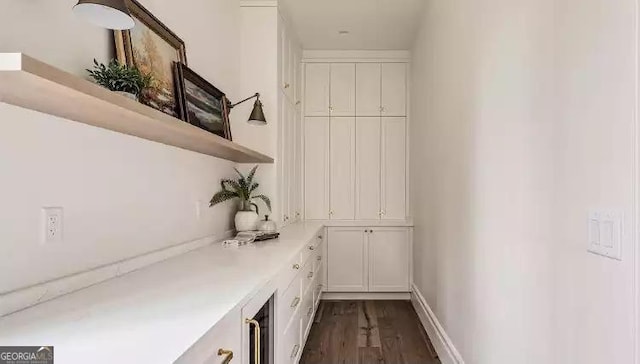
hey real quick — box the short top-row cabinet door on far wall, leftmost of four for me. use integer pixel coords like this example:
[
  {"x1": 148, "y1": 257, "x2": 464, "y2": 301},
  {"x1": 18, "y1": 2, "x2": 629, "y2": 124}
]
[{"x1": 304, "y1": 63, "x2": 331, "y2": 116}]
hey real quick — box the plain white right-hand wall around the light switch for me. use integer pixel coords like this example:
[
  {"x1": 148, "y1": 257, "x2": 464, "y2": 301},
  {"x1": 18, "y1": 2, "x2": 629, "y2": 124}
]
[{"x1": 411, "y1": 0, "x2": 636, "y2": 364}]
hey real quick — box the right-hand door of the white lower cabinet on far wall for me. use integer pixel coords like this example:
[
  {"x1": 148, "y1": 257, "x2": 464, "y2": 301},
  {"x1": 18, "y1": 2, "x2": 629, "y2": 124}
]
[{"x1": 367, "y1": 227, "x2": 411, "y2": 292}]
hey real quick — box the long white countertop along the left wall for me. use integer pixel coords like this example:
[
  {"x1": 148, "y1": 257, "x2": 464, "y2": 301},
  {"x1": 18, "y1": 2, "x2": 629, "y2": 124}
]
[{"x1": 0, "y1": 222, "x2": 323, "y2": 364}]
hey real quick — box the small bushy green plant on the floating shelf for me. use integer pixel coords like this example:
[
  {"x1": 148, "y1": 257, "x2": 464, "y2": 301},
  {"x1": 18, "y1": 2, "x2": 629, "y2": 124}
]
[{"x1": 87, "y1": 59, "x2": 153, "y2": 100}]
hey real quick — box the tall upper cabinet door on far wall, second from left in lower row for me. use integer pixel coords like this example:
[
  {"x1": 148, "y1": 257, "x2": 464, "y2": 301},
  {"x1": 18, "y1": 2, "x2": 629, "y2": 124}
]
[{"x1": 329, "y1": 117, "x2": 356, "y2": 220}]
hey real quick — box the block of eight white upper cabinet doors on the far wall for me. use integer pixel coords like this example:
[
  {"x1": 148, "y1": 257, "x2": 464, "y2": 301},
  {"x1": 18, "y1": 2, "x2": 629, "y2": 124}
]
[{"x1": 304, "y1": 63, "x2": 407, "y2": 220}]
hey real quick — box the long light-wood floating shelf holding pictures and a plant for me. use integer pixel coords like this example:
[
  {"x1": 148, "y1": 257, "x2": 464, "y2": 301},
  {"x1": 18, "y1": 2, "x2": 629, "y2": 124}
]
[{"x1": 0, "y1": 53, "x2": 273, "y2": 163}]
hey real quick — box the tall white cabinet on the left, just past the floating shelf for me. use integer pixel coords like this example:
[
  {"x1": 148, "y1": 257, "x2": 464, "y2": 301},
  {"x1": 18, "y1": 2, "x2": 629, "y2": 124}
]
[{"x1": 240, "y1": 2, "x2": 304, "y2": 225}]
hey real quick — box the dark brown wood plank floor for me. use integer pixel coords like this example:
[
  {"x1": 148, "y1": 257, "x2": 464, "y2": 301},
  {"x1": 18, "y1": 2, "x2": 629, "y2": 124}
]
[{"x1": 300, "y1": 301, "x2": 440, "y2": 364}]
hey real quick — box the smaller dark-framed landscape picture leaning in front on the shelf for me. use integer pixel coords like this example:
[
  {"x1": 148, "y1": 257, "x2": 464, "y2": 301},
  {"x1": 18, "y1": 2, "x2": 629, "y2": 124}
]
[{"x1": 174, "y1": 62, "x2": 231, "y2": 140}]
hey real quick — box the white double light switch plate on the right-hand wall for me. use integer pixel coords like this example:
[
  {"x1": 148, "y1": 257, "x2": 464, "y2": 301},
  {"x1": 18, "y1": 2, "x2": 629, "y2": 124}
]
[{"x1": 587, "y1": 210, "x2": 623, "y2": 260}]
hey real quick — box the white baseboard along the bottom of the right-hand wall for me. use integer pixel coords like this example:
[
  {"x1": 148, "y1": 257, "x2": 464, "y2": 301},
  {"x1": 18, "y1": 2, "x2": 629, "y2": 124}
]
[{"x1": 411, "y1": 284, "x2": 464, "y2": 364}]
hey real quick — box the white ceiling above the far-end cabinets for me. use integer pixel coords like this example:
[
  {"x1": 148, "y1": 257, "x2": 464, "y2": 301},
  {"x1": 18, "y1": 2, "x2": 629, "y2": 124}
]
[{"x1": 281, "y1": 0, "x2": 425, "y2": 50}]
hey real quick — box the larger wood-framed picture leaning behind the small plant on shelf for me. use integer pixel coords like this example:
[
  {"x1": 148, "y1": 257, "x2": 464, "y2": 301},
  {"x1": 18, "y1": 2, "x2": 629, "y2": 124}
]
[{"x1": 114, "y1": 0, "x2": 187, "y2": 117}]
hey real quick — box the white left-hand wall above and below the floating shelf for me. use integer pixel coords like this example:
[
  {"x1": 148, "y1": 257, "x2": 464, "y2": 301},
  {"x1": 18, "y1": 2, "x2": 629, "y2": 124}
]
[{"x1": 0, "y1": 0, "x2": 246, "y2": 293}]
